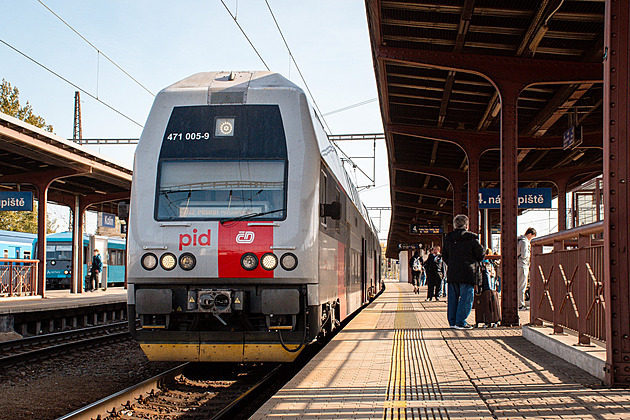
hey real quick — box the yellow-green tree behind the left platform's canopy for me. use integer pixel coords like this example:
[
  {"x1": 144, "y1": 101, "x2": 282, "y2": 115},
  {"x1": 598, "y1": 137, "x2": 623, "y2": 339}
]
[{"x1": 0, "y1": 79, "x2": 56, "y2": 233}]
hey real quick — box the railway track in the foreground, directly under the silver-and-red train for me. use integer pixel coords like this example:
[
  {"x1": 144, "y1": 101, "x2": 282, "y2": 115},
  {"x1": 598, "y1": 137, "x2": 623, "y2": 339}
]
[{"x1": 58, "y1": 363, "x2": 284, "y2": 420}]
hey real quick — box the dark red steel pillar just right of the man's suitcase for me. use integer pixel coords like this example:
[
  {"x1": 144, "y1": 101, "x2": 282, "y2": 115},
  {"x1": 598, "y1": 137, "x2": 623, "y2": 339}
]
[{"x1": 499, "y1": 83, "x2": 521, "y2": 326}]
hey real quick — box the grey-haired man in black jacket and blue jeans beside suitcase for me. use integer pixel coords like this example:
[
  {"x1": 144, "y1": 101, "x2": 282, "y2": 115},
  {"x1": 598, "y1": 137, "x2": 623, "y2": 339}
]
[{"x1": 442, "y1": 214, "x2": 485, "y2": 329}]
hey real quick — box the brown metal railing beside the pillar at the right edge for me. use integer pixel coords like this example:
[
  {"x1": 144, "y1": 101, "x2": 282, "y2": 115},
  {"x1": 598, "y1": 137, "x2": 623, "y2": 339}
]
[{"x1": 530, "y1": 221, "x2": 606, "y2": 345}]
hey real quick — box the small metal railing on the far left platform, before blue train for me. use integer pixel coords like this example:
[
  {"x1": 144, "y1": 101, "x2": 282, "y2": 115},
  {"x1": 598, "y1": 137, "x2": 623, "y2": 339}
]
[{"x1": 0, "y1": 258, "x2": 39, "y2": 296}]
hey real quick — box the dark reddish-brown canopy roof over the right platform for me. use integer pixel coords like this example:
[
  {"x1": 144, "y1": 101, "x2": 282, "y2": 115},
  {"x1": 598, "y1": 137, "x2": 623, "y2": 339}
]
[{"x1": 366, "y1": 0, "x2": 606, "y2": 257}]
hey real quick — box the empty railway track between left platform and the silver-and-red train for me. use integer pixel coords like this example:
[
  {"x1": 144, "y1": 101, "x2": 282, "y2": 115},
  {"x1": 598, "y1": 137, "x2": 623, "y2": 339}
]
[{"x1": 0, "y1": 321, "x2": 129, "y2": 366}]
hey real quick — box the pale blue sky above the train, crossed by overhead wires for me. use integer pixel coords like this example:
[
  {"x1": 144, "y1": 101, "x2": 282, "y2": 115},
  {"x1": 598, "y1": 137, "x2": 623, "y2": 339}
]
[{"x1": 0, "y1": 0, "x2": 389, "y2": 238}]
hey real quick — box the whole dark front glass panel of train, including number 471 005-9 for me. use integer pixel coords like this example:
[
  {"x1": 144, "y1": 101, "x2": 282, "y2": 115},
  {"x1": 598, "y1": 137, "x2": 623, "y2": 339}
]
[{"x1": 154, "y1": 105, "x2": 289, "y2": 220}]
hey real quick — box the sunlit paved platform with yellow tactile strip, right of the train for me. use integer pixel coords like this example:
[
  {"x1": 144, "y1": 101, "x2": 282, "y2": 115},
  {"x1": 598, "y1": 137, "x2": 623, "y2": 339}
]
[{"x1": 252, "y1": 283, "x2": 630, "y2": 419}]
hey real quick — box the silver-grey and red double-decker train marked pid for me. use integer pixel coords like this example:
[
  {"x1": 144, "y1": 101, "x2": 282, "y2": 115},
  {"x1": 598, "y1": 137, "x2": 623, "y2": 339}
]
[{"x1": 128, "y1": 72, "x2": 381, "y2": 362}]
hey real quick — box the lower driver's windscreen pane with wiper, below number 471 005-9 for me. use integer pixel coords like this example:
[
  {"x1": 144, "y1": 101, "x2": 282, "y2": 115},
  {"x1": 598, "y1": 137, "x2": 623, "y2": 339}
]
[{"x1": 157, "y1": 160, "x2": 285, "y2": 220}]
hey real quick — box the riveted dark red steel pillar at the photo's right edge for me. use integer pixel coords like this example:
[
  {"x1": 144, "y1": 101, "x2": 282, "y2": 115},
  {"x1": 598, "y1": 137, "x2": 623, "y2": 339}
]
[{"x1": 603, "y1": 0, "x2": 630, "y2": 386}]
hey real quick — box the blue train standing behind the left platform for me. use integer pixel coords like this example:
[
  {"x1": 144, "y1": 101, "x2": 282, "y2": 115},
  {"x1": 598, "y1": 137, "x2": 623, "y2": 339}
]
[{"x1": 0, "y1": 230, "x2": 126, "y2": 289}]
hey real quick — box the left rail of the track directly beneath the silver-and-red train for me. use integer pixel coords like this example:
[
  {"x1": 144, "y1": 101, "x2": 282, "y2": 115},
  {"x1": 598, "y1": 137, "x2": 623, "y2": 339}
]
[{"x1": 57, "y1": 363, "x2": 188, "y2": 420}]
